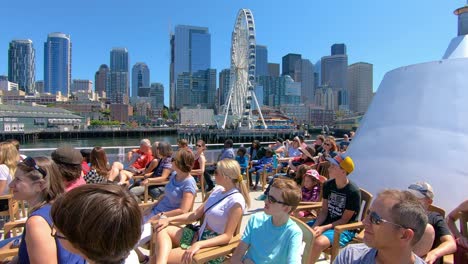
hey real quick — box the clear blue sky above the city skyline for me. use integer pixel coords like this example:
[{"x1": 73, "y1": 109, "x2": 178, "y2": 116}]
[{"x1": 0, "y1": 0, "x2": 460, "y2": 104}]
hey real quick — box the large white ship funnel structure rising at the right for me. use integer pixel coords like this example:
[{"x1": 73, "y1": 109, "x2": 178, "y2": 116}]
[{"x1": 348, "y1": 3, "x2": 468, "y2": 211}]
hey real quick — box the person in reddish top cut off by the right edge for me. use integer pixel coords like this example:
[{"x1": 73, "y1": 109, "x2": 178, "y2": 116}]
[{"x1": 447, "y1": 200, "x2": 468, "y2": 264}]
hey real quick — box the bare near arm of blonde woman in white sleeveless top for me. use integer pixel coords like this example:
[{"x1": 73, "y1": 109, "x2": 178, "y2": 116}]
[{"x1": 182, "y1": 203, "x2": 242, "y2": 263}]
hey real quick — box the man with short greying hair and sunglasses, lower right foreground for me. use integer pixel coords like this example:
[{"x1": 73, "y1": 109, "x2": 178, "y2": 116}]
[{"x1": 334, "y1": 190, "x2": 427, "y2": 264}]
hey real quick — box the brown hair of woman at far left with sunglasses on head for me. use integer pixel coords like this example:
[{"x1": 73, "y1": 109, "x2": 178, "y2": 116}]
[{"x1": 17, "y1": 157, "x2": 65, "y2": 214}]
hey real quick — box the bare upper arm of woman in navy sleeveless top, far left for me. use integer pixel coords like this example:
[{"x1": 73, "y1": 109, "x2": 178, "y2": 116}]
[{"x1": 26, "y1": 216, "x2": 58, "y2": 264}]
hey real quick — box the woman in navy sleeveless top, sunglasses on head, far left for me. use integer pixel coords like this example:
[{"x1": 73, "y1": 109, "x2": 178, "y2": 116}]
[{"x1": 10, "y1": 157, "x2": 85, "y2": 264}]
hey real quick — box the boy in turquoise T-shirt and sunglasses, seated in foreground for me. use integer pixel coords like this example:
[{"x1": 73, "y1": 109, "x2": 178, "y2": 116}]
[{"x1": 231, "y1": 178, "x2": 302, "y2": 263}]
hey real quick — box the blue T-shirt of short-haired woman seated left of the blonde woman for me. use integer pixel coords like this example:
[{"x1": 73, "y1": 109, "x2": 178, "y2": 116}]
[{"x1": 152, "y1": 175, "x2": 197, "y2": 215}]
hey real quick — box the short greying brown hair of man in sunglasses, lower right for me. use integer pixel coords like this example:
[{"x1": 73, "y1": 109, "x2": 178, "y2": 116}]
[{"x1": 377, "y1": 190, "x2": 428, "y2": 245}]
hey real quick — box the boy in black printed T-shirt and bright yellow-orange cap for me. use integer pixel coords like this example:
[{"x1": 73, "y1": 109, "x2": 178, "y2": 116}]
[{"x1": 307, "y1": 155, "x2": 361, "y2": 263}]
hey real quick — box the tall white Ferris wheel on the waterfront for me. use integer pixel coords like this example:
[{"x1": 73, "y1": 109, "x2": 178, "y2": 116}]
[{"x1": 222, "y1": 9, "x2": 267, "y2": 129}]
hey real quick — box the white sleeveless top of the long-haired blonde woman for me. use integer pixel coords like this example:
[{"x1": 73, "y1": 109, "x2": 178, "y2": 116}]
[{"x1": 199, "y1": 186, "x2": 245, "y2": 239}]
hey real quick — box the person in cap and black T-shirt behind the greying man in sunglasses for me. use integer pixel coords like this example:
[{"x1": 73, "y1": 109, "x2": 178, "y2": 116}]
[{"x1": 408, "y1": 182, "x2": 457, "y2": 264}]
